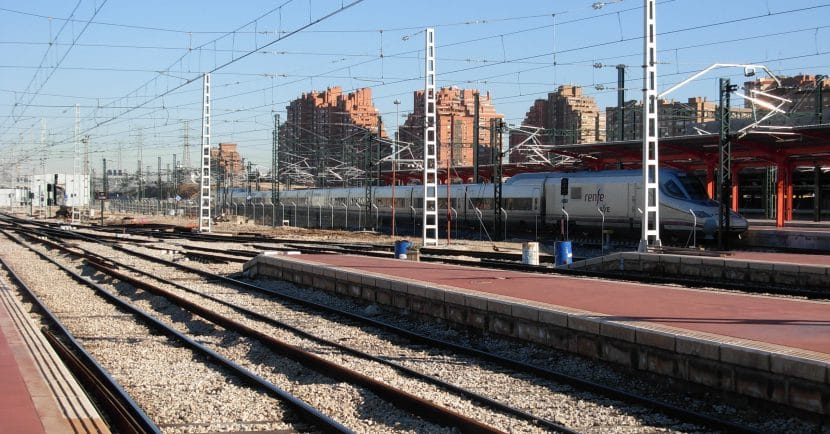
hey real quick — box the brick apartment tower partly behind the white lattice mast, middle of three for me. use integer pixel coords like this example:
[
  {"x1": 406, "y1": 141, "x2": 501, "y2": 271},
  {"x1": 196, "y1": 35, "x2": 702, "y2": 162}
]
[{"x1": 399, "y1": 86, "x2": 504, "y2": 178}]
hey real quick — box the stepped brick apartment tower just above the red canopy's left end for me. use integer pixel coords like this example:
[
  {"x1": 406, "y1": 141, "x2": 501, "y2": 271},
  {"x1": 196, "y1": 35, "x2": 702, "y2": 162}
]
[{"x1": 510, "y1": 85, "x2": 605, "y2": 162}]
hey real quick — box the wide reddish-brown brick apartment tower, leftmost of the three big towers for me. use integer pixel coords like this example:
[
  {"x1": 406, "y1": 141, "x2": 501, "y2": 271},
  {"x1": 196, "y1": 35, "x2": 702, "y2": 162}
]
[{"x1": 280, "y1": 86, "x2": 388, "y2": 186}]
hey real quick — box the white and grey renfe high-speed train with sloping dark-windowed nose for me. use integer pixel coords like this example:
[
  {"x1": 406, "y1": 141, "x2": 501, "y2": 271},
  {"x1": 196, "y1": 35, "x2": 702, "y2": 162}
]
[{"x1": 230, "y1": 169, "x2": 748, "y2": 239}]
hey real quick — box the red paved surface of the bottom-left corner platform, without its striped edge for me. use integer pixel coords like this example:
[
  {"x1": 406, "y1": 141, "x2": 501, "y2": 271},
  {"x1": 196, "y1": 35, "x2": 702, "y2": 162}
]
[{"x1": 0, "y1": 303, "x2": 45, "y2": 434}]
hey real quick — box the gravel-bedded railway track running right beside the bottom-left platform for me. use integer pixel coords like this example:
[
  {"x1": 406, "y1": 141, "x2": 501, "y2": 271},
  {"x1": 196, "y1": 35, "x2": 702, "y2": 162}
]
[{"x1": 0, "y1": 231, "x2": 351, "y2": 432}]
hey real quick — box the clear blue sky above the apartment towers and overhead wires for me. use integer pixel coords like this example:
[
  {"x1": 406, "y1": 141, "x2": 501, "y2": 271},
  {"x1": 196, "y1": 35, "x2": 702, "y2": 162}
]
[{"x1": 0, "y1": 0, "x2": 830, "y2": 172}]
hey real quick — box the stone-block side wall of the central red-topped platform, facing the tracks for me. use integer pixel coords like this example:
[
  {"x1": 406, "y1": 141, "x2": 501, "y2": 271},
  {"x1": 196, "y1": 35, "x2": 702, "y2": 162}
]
[{"x1": 244, "y1": 255, "x2": 830, "y2": 416}]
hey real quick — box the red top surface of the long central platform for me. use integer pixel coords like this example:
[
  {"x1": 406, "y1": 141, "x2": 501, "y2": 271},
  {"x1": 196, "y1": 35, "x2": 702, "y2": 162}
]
[{"x1": 292, "y1": 255, "x2": 830, "y2": 354}]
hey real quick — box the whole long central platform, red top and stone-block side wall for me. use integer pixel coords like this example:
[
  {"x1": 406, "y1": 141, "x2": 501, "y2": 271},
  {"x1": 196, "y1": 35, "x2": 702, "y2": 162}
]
[{"x1": 244, "y1": 252, "x2": 830, "y2": 416}]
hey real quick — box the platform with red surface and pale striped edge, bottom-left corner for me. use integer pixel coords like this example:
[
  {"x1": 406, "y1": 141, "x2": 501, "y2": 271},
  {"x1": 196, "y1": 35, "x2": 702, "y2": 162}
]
[{"x1": 0, "y1": 282, "x2": 110, "y2": 434}]
